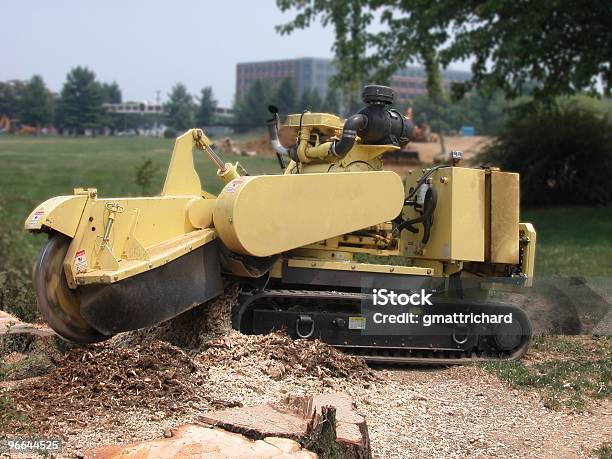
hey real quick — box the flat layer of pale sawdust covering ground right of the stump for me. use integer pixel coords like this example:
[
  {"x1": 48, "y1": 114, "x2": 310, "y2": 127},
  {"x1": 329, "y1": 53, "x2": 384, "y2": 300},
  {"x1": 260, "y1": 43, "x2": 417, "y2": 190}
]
[{"x1": 347, "y1": 366, "x2": 612, "y2": 459}]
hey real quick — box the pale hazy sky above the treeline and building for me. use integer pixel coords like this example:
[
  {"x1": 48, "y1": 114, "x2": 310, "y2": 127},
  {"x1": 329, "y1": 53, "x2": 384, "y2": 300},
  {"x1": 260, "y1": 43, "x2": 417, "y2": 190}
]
[{"x1": 0, "y1": 0, "x2": 468, "y2": 106}]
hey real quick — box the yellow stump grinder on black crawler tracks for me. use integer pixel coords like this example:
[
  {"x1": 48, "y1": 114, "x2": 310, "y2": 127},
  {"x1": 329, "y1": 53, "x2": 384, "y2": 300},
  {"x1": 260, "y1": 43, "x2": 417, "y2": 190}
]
[{"x1": 25, "y1": 86, "x2": 536, "y2": 363}]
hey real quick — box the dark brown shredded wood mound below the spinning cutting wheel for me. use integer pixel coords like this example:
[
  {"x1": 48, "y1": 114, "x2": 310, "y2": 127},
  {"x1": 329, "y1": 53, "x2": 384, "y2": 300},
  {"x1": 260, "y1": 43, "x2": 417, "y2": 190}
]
[{"x1": 6, "y1": 342, "x2": 199, "y2": 430}]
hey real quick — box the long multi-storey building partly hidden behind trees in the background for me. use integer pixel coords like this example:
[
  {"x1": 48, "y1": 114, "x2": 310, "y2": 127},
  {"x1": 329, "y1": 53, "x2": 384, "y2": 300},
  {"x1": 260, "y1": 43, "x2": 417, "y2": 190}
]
[{"x1": 236, "y1": 57, "x2": 471, "y2": 102}]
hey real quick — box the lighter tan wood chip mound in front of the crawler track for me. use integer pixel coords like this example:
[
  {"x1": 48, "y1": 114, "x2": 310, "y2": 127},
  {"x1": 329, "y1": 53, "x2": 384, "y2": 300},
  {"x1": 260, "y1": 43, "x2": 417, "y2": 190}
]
[{"x1": 196, "y1": 332, "x2": 374, "y2": 381}]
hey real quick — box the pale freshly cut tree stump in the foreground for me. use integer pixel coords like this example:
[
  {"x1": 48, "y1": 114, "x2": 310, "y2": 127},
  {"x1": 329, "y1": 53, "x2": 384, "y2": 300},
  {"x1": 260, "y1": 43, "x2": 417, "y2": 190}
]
[{"x1": 82, "y1": 394, "x2": 371, "y2": 459}]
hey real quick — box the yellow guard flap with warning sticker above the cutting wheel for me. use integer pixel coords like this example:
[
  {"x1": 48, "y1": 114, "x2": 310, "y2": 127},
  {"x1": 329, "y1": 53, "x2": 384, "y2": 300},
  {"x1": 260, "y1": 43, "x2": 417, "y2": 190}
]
[{"x1": 24, "y1": 195, "x2": 87, "y2": 237}]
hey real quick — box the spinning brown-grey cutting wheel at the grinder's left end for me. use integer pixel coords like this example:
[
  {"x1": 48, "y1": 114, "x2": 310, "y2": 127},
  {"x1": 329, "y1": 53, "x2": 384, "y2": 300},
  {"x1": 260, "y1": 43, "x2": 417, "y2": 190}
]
[{"x1": 34, "y1": 234, "x2": 110, "y2": 344}]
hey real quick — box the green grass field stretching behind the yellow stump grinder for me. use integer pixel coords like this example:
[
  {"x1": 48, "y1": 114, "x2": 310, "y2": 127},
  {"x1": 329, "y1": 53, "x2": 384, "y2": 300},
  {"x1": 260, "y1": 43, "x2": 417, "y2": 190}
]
[{"x1": 0, "y1": 136, "x2": 612, "y2": 320}]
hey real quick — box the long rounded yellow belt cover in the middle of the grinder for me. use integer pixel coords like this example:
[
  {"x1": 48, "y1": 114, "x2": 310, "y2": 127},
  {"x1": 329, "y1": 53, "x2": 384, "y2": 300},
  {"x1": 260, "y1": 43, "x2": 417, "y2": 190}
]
[{"x1": 213, "y1": 171, "x2": 404, "y2": 257}]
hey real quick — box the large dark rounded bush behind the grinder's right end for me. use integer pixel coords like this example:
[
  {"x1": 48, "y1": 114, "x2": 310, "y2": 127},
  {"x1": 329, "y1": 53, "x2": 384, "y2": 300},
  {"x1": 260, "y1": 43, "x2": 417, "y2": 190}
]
[{"x1": 478, "y1": 98, "x2": 612, "y2": 205}]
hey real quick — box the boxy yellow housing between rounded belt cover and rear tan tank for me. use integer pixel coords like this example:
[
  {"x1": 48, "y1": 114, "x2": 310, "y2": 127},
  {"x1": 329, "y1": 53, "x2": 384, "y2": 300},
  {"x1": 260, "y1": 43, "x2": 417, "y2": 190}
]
[{"x1": 402, "y1": 167, "x2": 485, "y2": 261}]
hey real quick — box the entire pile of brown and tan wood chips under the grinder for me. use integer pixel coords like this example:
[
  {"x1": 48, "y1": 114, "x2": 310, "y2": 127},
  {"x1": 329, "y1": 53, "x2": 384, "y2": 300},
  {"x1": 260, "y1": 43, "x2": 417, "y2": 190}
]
[{"x1": 3, "y1": 289, "x2": 375, "y2": 440}]
